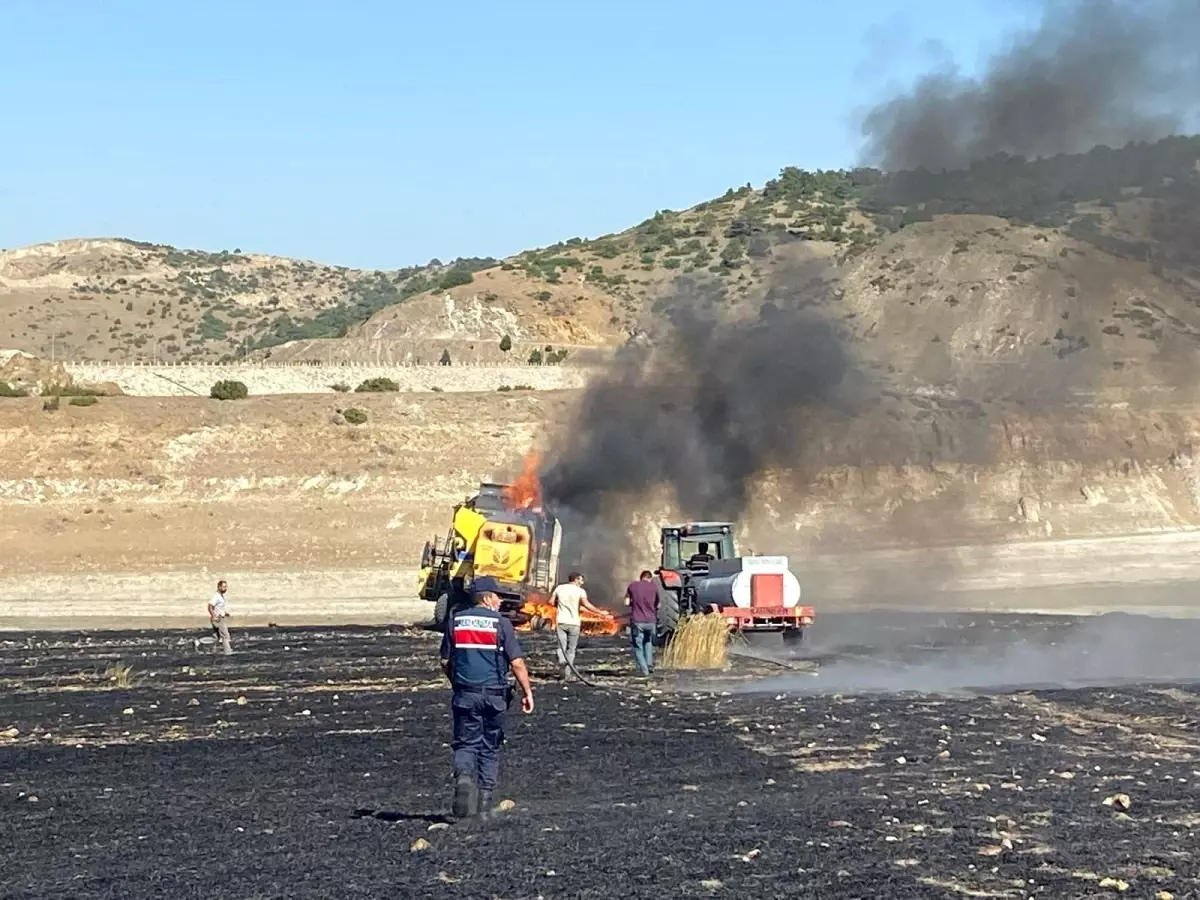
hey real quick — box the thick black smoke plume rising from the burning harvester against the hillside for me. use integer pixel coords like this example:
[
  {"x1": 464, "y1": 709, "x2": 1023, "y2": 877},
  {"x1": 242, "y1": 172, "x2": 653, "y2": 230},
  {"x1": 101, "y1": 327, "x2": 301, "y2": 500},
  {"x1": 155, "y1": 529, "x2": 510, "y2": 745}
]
[{"x1": 540, "y1": 271, "x2": 857, "y2": 592}]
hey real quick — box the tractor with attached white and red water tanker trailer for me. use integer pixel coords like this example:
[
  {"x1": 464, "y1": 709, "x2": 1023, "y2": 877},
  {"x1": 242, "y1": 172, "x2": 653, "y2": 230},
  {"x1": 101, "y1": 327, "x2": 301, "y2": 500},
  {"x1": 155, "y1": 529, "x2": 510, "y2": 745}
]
[{"x1": 658, "y1": 522, "x2": 814, "y2": 643}]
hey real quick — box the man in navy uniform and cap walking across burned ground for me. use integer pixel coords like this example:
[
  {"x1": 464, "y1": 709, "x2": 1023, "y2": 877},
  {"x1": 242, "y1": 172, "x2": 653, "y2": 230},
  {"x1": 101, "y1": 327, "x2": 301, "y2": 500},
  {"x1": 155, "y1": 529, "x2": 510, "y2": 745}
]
[{"x1": 442, "y1": 577, "x2": 533, "y2": 818}]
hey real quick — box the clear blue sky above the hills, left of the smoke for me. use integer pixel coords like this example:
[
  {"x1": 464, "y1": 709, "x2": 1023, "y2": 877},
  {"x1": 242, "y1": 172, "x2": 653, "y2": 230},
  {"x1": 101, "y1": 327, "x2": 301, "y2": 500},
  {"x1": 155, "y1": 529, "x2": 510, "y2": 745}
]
[{"x1": 0, "y1": 0, "x2": 1030, "y2": 269}]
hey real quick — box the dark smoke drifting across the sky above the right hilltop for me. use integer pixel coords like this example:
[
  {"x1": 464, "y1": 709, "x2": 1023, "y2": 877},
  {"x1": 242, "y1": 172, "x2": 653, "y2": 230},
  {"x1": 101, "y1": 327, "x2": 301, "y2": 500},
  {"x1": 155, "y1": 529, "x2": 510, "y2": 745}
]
[{"x1": 863, "y1": 0, "x2": 1200, "y2": 172}]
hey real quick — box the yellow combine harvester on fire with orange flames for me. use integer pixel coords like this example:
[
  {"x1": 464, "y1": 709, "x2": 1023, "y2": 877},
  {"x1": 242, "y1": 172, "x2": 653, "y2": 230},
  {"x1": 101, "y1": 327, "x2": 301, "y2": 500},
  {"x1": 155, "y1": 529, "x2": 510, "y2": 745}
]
[{"x1": 418, "y1": 457, "x2": 623, "y2": 635}]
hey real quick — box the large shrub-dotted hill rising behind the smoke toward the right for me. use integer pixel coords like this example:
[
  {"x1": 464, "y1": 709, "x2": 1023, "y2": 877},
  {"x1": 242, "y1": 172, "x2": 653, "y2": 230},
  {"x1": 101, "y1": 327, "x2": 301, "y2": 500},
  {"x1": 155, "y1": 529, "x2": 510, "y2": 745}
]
[{"x1": 241, "y1": 132, "x2": 1200, "y2": 380}]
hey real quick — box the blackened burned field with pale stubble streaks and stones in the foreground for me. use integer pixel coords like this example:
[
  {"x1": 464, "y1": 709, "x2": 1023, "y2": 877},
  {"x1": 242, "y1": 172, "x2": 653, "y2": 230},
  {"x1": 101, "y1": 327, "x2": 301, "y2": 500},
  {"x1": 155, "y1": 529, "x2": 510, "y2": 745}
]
[{"x1": 0, "y1": 617, "x2": 1200, "y2": 898}]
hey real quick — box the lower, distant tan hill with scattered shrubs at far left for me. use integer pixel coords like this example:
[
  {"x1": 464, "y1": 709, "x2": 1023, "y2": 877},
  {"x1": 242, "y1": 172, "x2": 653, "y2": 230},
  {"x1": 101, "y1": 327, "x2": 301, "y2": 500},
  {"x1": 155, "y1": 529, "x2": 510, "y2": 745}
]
[{"x1": 0, "y1": 239, "x2": 494, "y2": 362}]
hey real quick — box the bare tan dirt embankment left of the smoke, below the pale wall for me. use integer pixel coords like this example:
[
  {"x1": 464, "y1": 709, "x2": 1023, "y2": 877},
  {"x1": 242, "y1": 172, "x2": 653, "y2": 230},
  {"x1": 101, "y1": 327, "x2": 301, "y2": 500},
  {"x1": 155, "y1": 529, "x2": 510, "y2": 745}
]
[{"x1": 0, "y1": 392, "x2": 563, "y2": 575}]
